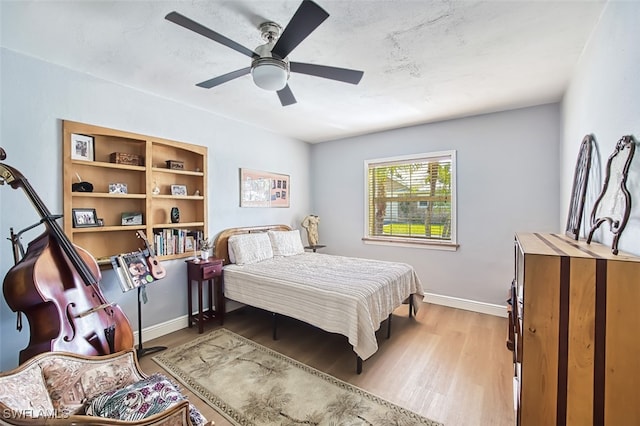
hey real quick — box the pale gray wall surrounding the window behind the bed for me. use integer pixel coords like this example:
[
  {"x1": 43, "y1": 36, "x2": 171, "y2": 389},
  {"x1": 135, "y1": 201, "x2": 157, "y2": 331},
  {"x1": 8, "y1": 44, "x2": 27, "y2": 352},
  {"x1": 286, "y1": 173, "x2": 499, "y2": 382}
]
[{"x1": 311, "y1": 104, "x2": 560, "y2": 305}]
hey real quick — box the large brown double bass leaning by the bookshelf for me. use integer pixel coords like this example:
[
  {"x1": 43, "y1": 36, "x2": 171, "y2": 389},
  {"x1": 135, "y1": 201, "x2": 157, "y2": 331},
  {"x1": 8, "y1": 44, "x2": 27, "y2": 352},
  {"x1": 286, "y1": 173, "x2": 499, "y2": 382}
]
[{"x1": 0, "y1": 148, "x2": 133, "y2": 364}]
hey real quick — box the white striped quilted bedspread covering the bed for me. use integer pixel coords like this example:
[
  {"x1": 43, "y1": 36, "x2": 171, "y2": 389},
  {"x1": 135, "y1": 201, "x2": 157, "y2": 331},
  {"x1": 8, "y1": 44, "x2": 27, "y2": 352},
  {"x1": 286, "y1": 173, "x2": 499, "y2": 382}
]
[{"x1": 224, "y1": 253, "x2": 424, "y2": 360}]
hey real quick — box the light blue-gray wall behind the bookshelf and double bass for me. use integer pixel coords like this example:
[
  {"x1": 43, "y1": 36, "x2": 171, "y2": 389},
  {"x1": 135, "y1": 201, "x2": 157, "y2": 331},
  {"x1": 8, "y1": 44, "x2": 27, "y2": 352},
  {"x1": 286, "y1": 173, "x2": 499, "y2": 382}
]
[{"x1": 0, "y1": 49, "x2": 310, "y2": 370}]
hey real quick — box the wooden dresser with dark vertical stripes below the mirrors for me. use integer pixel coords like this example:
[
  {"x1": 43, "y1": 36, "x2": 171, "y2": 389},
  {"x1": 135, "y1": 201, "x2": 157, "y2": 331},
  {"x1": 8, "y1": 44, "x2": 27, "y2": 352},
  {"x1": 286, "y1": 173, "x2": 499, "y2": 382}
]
[{"x1": 508, "y1": 233, "x2": 640, "y2": 426}]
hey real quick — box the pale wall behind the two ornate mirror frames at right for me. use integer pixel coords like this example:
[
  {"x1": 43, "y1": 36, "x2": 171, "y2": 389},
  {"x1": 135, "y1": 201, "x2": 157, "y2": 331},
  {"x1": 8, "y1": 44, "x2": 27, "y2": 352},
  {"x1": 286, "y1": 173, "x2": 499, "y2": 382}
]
[{"x1": 560, "y1": 1, "x2": 640, "y2": 255}]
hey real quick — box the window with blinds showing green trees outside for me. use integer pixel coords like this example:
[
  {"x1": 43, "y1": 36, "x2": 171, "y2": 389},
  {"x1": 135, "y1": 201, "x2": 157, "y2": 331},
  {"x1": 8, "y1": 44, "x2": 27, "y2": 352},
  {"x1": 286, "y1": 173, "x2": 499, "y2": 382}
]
[{"x1": 364, "y1": 151, "x2": 457, "y2": 250}]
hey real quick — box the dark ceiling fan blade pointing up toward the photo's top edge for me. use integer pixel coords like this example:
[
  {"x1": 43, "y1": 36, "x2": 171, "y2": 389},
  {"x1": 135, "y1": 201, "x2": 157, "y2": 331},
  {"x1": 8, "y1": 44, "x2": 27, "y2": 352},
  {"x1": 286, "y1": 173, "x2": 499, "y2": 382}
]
[{"x1": 271, "y1": 0, "x2": 329, "y2": 59}]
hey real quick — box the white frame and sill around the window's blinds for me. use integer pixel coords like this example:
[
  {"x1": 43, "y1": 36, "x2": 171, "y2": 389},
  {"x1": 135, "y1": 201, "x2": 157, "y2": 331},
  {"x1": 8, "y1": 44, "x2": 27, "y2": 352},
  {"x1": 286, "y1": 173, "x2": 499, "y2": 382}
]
[{"x1": 362, "y1": 150, "x2": 459, "y2": 251}]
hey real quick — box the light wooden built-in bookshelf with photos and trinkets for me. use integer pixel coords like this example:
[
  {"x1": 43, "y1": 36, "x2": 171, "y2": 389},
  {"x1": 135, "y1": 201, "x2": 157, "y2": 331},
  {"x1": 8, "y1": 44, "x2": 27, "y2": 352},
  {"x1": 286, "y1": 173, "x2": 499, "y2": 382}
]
[{"x1": 62, "y1": 120, "x2": 207, "y2": 265}]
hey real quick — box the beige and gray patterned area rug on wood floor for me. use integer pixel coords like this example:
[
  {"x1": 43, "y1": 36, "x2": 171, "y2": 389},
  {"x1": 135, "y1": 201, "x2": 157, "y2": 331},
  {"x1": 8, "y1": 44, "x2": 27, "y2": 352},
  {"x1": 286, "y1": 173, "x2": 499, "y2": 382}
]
[{"x1": 153, "y1": 328, "x2": 442, "y2": 426}]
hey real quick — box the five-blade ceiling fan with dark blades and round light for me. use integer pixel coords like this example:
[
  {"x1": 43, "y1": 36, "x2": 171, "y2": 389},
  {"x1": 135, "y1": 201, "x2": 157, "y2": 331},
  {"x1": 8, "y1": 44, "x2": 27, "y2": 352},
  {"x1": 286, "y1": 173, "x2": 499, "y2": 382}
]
[{"x1": 165, "y1": 0, "x2": 364, "y2": 106}]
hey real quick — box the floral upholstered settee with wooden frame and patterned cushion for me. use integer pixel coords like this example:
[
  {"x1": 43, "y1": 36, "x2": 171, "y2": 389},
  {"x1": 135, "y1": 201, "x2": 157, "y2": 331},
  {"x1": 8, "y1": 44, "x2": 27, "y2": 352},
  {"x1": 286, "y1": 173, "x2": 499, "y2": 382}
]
[{"x1": 0, "y1": 349, "x2": 213, "y2": 426}]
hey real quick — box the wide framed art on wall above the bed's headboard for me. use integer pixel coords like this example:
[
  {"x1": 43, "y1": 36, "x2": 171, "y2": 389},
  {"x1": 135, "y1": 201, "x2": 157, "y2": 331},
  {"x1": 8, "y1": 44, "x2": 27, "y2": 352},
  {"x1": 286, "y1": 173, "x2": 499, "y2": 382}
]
[{"x1": 240, "y1": 169, "x2": 291, "y2": 207}]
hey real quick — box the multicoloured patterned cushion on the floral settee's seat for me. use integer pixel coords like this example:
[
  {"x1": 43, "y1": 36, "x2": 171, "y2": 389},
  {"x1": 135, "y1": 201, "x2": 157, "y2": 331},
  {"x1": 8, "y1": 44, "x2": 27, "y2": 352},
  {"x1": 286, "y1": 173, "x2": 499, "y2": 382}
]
[{"x1": 86, "y1": 374, "x2": 206, "y2": 426}]
